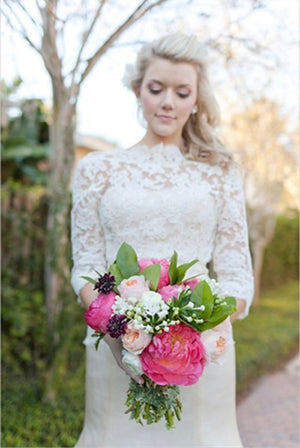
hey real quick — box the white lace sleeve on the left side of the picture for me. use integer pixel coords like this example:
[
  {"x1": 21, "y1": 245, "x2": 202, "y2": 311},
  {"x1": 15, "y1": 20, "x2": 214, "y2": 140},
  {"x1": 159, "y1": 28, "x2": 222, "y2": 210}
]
[{"x1": 71, "y1": 153, "x2": 107, "y2": 300}]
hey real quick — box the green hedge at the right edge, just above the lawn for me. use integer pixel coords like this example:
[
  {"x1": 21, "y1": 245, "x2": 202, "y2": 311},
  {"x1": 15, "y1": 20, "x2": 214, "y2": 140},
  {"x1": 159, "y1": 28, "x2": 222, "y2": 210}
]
[{"x1": 261, "y1": 213, "x2": 299, "y2": 290}]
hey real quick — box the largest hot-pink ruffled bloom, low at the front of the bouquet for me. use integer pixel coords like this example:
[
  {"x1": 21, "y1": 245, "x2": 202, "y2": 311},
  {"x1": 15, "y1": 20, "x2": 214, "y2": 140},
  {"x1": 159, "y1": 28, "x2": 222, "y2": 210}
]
[{"x1": 141, "y1": 323, "x2": 205, "y2": 386}]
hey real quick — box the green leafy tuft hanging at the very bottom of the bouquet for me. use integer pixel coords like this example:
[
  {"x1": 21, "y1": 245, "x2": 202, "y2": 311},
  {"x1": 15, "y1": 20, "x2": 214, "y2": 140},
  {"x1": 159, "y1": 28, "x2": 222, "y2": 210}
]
[{"x1": 125, "y1": 375, "x2": 182, "y2": 429}]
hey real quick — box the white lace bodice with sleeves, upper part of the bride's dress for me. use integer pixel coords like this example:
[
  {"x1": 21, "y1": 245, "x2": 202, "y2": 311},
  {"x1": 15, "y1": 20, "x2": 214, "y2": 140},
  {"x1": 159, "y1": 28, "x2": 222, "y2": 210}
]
[{"x1": 71, "y1": 144, "x2": 253, "y2": 317}]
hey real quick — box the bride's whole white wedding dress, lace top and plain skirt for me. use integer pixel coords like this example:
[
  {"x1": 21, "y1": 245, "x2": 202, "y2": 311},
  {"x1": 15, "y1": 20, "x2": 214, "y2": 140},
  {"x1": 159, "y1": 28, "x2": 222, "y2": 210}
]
[{"x1": 72, "y1": 144, "x2": 253, "y2": 448}]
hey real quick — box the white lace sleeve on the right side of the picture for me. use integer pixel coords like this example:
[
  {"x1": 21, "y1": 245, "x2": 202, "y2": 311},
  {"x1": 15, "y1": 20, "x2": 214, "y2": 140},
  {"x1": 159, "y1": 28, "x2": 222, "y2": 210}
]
[{"x1": 213, "y1": 165, "x2": 254, "y2": 319}]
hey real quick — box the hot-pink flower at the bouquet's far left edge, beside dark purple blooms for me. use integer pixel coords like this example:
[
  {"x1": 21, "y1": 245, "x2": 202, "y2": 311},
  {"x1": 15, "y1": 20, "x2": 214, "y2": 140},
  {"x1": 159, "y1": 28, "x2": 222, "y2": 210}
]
[{"x1": 84, "y1": 292, "x2": 116, "y2": 333}]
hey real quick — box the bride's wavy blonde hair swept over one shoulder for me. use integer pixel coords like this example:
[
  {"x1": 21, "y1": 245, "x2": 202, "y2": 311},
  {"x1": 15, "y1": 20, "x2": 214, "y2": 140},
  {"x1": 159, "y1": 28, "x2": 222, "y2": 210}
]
[{"x1": 124, "y1": 33, "x2": 232, "y2": 164}]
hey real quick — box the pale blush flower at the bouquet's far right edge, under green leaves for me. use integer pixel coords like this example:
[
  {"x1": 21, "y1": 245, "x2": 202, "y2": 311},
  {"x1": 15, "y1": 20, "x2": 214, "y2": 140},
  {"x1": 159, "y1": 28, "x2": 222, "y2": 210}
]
[{"x1": 201, "y1": 318, "x2": 234, "y2": 364}]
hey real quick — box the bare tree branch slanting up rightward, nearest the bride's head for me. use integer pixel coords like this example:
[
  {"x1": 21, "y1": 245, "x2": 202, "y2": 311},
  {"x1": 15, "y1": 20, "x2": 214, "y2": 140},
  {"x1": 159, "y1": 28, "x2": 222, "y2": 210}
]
[{"x1": 78, "y1": 0, "x2": 168, "y2": 87}]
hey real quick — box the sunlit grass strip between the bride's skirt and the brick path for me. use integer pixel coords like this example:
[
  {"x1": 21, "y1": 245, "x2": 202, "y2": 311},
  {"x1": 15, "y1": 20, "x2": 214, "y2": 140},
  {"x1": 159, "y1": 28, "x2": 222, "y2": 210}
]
[{"x1": 234, "y1": 281, "x2": 299, "y2": 397}]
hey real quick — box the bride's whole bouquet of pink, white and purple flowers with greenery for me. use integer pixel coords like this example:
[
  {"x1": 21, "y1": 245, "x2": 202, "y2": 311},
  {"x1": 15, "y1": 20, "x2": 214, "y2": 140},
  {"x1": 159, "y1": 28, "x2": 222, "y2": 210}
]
[{"x1": 83, "y1": 243, "x2": 236, "y2": 429}]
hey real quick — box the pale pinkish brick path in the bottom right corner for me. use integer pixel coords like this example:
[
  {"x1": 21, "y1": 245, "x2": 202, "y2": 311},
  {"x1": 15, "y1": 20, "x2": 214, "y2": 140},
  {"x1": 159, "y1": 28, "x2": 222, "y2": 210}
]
[{"x1": 237, "y1": 357, "x2": 300, "y2": 448}]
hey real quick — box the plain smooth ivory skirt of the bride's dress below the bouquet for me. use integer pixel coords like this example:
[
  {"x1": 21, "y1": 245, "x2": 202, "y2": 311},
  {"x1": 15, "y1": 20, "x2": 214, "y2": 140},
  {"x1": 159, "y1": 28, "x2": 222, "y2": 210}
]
[{"x1": 76, "y1": 341, "x2": 242, "y2": 448}]
